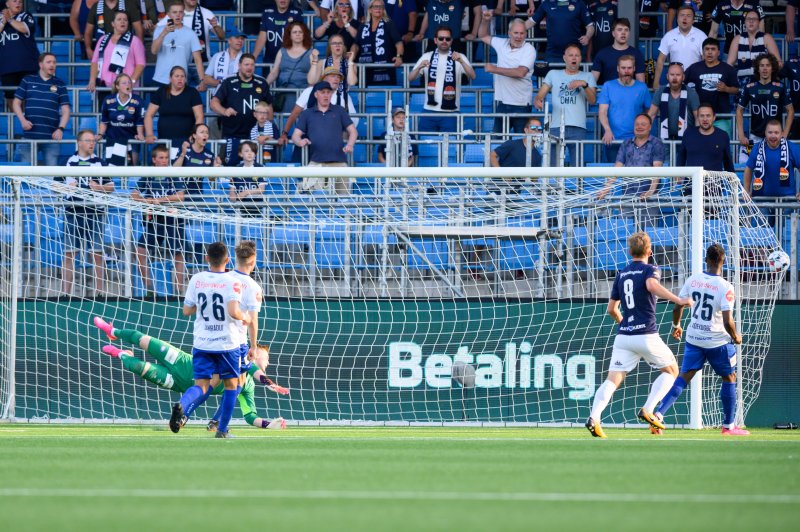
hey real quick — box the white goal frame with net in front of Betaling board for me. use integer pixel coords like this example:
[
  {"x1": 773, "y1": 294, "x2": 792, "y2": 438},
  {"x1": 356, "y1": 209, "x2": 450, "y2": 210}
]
[{"x1": 0, "y1": 166, "x2": 785, "y2": 428}]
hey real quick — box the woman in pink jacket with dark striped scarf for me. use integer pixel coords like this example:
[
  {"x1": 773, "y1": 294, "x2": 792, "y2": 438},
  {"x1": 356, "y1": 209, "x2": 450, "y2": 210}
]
[{"x1": 86, "y1": 11, "x2": 145, "y2": 92}]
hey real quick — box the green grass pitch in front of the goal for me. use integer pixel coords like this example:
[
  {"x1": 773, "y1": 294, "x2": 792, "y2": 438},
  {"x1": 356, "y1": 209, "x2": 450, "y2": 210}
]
[{"x1": 0, "y1": 424, "x2": 800, "y2": 532}]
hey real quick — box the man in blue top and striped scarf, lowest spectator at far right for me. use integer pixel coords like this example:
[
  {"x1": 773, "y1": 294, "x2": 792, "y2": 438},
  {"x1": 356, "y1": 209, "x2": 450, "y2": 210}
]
[{"x1": 744, "y1": 120, "x2": 800, "y2": 203}]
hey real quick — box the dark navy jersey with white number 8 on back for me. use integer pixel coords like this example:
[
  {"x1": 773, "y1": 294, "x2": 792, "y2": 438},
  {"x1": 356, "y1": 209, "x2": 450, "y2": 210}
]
[{"x1": 611, "y1": 260, "x2": 661, "y2": 335}]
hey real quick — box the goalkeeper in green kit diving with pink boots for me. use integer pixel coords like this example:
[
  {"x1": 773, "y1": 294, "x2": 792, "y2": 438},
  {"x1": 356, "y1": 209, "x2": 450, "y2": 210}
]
[{"x1": 94, "y1": 317, "x2": 289, "y2": 431}]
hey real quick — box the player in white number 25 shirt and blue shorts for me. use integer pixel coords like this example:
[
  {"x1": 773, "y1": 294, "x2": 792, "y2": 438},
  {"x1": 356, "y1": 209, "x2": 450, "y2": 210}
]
[{"x1": 654, "y1": 244, "x2": 750, "y2": 436}]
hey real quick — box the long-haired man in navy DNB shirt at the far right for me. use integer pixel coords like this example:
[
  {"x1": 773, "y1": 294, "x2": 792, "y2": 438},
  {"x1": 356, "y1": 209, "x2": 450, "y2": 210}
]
[{"x1": 736, "y1": 54, "x2": 794, "y2": 162}]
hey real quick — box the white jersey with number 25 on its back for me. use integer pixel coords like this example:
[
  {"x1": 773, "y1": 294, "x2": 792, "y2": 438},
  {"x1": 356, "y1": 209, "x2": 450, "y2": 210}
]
[{"x1": 680, "y1": 272, "x2": 734, "y2": 348}]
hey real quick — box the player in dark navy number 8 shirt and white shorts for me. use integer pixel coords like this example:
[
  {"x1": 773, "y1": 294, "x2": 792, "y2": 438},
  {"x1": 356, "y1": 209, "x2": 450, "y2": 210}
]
[{"x1": 586, "y1": 232, "x2": 692, "y2": 438}]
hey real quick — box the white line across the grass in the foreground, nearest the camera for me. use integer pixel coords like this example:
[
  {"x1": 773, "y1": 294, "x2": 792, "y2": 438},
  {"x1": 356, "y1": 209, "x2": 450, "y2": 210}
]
[{"x1": 0, "y1": 488, "x2": 800, "y2": 505}]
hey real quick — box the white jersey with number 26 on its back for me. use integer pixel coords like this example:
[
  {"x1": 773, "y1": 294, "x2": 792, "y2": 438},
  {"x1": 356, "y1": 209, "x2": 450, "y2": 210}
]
[{"x1": 183, "y1": 271, "x2": 242, "y2": 352}]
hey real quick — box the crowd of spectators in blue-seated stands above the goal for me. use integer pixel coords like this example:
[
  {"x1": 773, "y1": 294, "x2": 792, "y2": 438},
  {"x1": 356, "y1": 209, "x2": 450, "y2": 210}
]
[{"x1": 0, "y1": 0, "x2": 800, "y2": 294}]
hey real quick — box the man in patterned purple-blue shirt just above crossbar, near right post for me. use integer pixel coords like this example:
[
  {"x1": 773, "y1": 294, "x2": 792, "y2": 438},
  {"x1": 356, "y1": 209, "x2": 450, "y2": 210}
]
[{"x1": 597, "y1": 113, "x2": 665, "y2": 199}]
